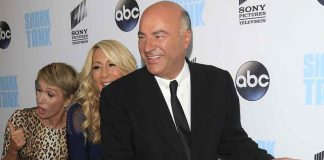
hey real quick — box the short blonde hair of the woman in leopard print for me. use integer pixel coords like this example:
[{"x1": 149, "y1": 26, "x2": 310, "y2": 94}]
[{"x1": 36, "y1": 63, "x2": 79, "y2": 99}]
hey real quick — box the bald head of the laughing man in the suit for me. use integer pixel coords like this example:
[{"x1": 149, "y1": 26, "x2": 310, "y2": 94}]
[{"x1": 138, "y1": 1, "x2": 192, "y2": 79}]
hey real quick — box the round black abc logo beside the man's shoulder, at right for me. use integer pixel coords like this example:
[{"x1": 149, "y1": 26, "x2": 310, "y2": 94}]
[{"x1": 235, "y1": 61, "x2": 270, "y2": 101}]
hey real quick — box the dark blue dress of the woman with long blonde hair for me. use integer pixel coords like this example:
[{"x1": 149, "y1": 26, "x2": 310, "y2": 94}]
[{"x1": 66, "y1": 103, "x2": 102, "y2": 160}]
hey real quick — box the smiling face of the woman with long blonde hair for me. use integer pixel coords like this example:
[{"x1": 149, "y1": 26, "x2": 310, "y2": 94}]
[{"x1": 92, "y1": 48, "x2": 123, "y2": 92}]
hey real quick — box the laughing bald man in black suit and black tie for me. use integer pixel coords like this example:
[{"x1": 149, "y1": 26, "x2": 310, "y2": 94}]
[{"x1": 100, "y1": 1, "x2": 296, "y2": 160}]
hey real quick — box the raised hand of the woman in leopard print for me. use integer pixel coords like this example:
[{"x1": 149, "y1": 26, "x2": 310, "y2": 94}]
[{"x1": 7, "y1": 122, "x2": 26, "y2": 152}]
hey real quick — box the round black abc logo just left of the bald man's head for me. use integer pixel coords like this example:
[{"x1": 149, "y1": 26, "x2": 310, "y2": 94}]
[{"x1": 115, "y1": 0, "x2": 140, "y2": 32}]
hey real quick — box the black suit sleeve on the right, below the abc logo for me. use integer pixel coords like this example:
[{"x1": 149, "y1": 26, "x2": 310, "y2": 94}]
[{"x1": 220, "y1": 72, "x2": 273, "y2": 160}]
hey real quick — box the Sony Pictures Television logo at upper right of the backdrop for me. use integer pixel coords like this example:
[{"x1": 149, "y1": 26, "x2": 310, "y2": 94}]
[{"x1": 238, "y1": 0, "x2": 267, "y2": 25}]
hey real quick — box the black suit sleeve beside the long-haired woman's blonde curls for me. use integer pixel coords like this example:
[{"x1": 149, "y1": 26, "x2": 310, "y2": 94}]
[{"x1": 100, "y1": 86, "x2": 134, "y2": 160}]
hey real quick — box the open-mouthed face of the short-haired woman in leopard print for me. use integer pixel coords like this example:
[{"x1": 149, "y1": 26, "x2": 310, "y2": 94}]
[{"x1": 36, "y1": 79, "x2": 65, "y2": 120}]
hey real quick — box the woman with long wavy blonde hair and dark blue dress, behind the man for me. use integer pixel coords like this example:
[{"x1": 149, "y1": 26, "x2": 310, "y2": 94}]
[{"x1": 67, "y1": 40, "x2": 136, "y2": 160}]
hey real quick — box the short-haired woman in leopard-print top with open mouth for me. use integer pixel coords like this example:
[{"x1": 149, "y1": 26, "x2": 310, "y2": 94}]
[{"x1": 2, "y1": 63, "x2": 79, "y2": 160}]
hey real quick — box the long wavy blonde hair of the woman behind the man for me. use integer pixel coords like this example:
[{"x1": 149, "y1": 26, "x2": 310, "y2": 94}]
[{"x1": 75, "y1": 40, "x2": 136, "y2": 143}]
